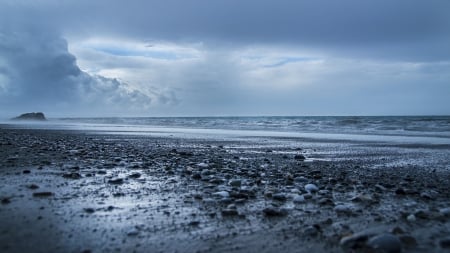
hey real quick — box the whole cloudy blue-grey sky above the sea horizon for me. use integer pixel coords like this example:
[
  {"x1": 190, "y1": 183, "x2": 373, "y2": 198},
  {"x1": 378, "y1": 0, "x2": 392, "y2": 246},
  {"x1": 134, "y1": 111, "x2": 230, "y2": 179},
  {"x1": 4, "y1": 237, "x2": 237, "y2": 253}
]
[{"x1": 0, "y1": 0, "x2": 450, "y2": 117}]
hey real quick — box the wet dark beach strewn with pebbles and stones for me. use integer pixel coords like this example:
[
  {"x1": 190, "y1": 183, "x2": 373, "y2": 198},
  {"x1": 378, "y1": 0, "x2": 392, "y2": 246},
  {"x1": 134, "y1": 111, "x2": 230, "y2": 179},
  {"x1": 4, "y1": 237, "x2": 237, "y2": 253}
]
[{"x1": 0, "y1": 126, "x2": 450, "y2": 252}]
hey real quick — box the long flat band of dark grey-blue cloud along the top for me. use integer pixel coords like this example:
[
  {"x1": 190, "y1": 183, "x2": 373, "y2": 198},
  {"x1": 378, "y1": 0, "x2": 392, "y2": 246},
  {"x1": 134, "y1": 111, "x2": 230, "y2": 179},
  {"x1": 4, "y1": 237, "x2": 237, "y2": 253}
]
[{"x1": 2, "y1": 0, "x2": 450, "y2": 60}]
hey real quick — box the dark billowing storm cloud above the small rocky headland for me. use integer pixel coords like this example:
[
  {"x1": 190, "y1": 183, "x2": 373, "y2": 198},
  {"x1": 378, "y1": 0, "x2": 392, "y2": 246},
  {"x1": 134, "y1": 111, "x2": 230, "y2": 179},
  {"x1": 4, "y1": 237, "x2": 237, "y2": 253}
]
[{"x1": 0, "y1": 29, "x2": 151, "y2": 114}]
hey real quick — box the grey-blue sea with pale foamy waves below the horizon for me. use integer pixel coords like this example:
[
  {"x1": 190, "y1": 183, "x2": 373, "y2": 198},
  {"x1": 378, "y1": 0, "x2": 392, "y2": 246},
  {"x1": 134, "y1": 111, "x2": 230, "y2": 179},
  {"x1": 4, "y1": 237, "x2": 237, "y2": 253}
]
[{"x1": 5, "y1": 116, "x2": 450, "y2": 145}]
